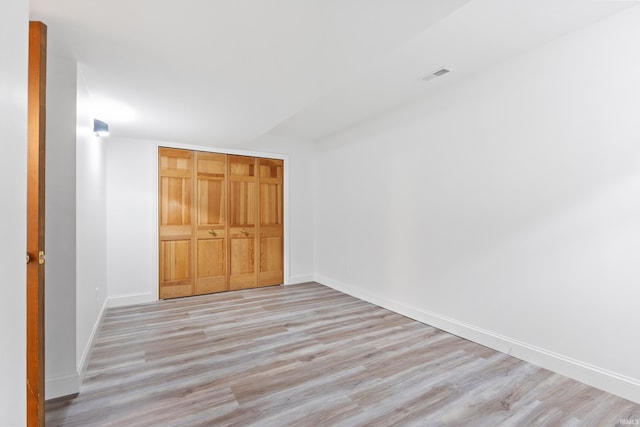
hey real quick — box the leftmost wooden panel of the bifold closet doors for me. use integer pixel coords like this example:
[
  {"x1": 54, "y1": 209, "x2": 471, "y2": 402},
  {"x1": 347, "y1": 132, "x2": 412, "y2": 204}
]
[{"x1": 158, "y1": 148, "x2": 194, "y2": 298}]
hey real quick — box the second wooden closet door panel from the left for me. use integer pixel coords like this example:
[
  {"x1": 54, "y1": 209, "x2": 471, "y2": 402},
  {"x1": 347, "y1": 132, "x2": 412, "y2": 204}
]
[{"x1": 194, "y1": 152, "x2": 227, "y2": 295}]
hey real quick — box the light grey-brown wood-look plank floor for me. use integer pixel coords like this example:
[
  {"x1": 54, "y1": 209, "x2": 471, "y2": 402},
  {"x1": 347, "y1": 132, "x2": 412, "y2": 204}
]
[{"x1": 46, "y1": 283, "x2": 640, "y2": 427}]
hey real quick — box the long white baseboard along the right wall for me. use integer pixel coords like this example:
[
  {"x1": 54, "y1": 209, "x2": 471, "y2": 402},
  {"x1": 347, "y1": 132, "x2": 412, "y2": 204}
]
[{"x1": 315, "y1": 275, "x2": 640, "y2": 403}]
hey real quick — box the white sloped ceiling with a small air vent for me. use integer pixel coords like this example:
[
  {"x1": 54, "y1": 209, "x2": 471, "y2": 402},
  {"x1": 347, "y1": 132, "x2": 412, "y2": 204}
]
[{"x1": 31, "y1": 0, "x2": 633, "y2": 146}]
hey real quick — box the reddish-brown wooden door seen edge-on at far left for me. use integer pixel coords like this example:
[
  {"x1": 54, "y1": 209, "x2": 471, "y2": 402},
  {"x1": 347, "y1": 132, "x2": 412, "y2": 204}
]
[{"x1": 26, "y1": 21, "x2": 47, "y2": 427}]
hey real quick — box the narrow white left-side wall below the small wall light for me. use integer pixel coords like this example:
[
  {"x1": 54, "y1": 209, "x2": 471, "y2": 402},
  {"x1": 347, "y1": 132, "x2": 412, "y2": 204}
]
[{"x1": 76, "y1": 68, "x2": 107, "y2": 375}]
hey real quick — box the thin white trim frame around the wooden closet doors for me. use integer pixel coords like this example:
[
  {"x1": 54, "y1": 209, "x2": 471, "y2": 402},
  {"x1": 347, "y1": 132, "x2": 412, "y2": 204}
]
[{"x1": 151, "y1": 143, "x2": 291, "y2": 302}]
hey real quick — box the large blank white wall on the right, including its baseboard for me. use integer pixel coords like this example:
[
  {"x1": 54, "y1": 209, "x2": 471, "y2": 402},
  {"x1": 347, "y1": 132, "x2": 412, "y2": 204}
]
[{"x1": 315, "y1": 7, "x2": 640, "y2": 402}]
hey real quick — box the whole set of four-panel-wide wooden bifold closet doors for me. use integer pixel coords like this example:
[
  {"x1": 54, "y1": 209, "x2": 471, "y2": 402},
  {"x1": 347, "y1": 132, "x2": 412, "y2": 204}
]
[{"x1": 158, "y1": 147, "x2": 284, "y2": 299}]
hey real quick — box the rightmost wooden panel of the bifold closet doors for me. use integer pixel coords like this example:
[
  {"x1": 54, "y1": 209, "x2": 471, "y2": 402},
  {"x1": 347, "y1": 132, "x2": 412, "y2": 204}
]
[{"x1": 258, "y1": 158, "x2": 284, "y2": 286}]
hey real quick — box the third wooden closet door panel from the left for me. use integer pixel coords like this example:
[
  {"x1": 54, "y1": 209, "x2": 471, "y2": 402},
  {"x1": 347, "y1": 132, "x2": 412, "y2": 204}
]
[{"x1": 227, "y1": 155, "x2": 258, "y2": 289}]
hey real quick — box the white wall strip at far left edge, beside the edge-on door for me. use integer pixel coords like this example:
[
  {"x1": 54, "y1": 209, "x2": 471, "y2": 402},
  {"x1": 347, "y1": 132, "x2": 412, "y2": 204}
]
[{"x1": 0, "y1": 0, "x2": 29, "y2": 426}]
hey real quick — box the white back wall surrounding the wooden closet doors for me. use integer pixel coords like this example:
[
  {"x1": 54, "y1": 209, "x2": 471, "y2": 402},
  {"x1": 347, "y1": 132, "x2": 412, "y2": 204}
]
[{"x1": 107, "y1": 137, "x2": 313, "y2": 306}]
